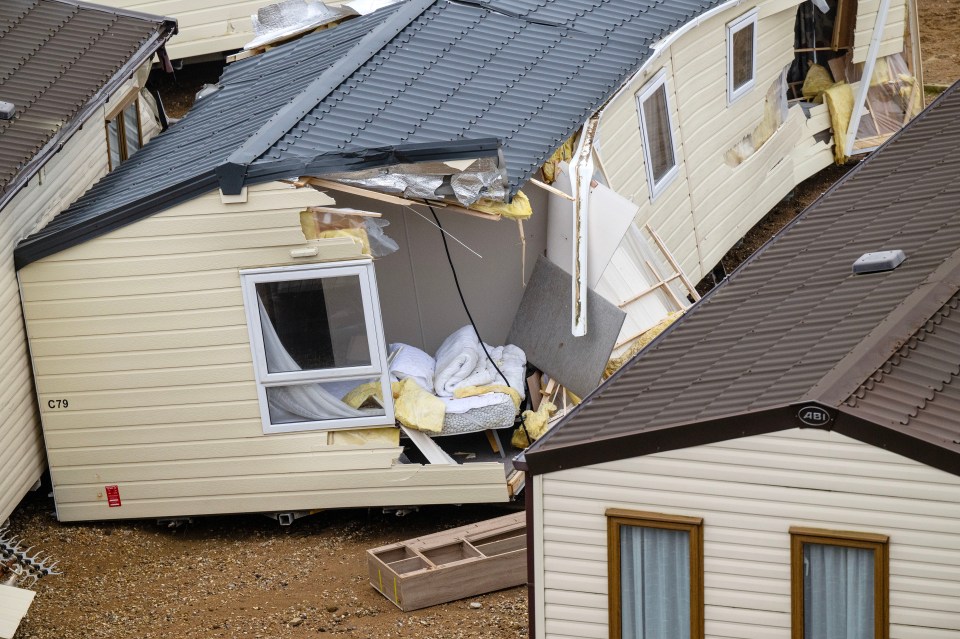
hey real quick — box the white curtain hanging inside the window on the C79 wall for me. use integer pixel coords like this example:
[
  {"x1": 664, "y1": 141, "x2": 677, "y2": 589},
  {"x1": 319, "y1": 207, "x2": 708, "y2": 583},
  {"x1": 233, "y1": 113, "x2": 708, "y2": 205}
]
[{"x1": 257, "y1": 296, "x2": 369, "y2": 424}]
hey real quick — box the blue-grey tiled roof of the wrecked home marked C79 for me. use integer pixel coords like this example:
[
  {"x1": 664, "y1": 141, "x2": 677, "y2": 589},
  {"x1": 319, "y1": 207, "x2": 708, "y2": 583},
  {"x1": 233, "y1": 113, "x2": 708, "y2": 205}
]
[{"x1": 17, "y1": 0, "x2": 720, "y2": 266}]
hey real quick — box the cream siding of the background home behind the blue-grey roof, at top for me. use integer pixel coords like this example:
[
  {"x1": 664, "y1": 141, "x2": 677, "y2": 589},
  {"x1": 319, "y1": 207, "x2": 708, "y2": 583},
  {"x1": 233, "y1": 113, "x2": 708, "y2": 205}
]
[{"x1": 99, "y1": 0, "x2": 352, "y2": 59}]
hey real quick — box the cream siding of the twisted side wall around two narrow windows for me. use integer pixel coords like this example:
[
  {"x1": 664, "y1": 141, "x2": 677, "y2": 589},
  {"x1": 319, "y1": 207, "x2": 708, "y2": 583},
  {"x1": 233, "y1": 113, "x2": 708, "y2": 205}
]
[{"x1": 599, "y1": 0, "x2": 831, "y2": 281}]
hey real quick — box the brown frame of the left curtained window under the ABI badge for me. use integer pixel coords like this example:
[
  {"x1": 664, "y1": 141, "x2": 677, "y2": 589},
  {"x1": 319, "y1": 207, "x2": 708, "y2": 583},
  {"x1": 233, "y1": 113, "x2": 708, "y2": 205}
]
[{"x1": 606, "y1": 508, "x2": 704, "y2": 639}]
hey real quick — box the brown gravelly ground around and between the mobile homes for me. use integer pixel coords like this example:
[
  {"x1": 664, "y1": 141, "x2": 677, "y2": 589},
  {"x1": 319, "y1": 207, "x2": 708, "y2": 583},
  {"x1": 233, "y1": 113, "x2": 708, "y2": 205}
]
[{"x1": 11, "y1": 0, "x2": 960, "y2": 639}]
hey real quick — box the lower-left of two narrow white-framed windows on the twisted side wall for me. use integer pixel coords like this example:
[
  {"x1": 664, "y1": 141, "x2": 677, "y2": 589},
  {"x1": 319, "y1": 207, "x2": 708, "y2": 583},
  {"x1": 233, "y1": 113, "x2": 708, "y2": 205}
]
[{"x1": 637, "y1": 71, "x2": 679, "y2": 200}]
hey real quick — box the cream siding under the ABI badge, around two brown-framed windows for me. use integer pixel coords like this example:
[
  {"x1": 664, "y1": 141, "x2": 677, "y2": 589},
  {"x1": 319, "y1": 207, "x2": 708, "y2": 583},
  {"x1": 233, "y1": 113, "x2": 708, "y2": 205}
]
[{"x1": 535, "y1": 429, "x2": 960, "y2": 639}]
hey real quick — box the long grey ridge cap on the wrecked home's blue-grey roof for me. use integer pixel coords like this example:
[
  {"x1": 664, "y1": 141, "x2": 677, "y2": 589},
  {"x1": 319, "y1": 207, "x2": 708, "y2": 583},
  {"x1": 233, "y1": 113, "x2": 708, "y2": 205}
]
[{"x1": 216, "y1": 0, "x2": 438, "y2": 194}]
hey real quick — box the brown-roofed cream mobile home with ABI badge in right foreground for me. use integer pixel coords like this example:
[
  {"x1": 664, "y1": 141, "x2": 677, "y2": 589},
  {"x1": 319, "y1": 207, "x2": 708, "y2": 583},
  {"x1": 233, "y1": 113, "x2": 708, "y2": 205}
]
[{"x1": 518, "y1": 84, "x2": 960, "y2": 639}]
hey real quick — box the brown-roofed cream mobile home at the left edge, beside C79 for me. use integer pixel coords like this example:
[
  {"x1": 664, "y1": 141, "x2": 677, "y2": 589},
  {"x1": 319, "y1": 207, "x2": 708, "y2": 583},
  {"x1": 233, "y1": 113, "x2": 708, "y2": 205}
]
[{"x1": 0, "y1": 0, "x2": 176, "y2": 524}]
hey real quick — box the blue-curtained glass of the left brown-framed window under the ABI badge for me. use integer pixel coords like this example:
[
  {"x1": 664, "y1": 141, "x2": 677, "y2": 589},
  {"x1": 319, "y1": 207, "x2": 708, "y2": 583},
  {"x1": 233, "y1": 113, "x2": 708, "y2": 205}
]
[{"x1": 620, "y1": 526, "x2": 690, "y2": 639}]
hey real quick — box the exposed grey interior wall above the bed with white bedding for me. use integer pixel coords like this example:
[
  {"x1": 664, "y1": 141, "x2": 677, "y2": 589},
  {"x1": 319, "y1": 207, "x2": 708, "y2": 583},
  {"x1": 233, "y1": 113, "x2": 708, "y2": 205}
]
[{"x1": 332, "y1": 188, "x2": 547, "y2": 353}]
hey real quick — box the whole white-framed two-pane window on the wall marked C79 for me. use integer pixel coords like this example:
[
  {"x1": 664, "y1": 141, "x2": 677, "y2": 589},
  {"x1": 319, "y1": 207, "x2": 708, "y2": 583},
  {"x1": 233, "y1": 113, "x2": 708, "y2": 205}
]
[{"x1": 241, "y1": 262, "x2": 393, "y2": 433}]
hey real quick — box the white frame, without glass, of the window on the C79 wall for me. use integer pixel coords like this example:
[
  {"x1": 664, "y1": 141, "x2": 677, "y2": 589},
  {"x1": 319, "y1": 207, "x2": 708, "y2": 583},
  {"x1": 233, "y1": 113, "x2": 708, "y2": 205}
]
[{"x1": 240, "y1": 260, "x2": 394, "y2": 434}]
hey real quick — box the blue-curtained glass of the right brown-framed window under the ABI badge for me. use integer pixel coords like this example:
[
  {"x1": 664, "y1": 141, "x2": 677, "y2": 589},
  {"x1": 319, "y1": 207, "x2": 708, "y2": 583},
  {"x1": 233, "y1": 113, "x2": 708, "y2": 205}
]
[{"x1": 803, "y1": 543, "x2": 875, "y2": 639}]
